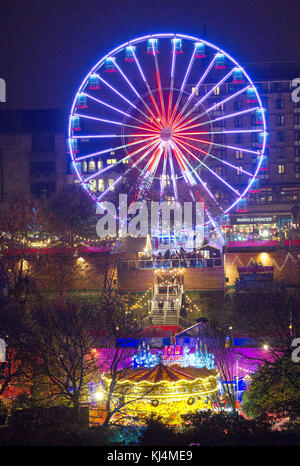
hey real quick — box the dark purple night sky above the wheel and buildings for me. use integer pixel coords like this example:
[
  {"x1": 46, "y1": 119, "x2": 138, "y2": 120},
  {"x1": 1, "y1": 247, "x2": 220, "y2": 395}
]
[{"x1": 0, "y1": 0, "x2": 300, "y2": 109}]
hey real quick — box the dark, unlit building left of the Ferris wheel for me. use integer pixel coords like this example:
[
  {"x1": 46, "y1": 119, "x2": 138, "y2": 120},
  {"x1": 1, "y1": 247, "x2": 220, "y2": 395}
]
[{"x1": 0, "y1": 109, "x2": 73, "y2": 206}]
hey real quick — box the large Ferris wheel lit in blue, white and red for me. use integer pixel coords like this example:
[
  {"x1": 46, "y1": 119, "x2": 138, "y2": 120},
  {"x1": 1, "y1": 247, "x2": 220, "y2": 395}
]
[{"x1": 68, "y1": 34, "x2": 267, "y2": 228}]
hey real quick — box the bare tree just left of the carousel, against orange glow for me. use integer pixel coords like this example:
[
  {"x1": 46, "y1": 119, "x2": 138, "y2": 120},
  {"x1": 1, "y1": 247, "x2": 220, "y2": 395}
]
[{"x1": 29, "y1": 302, "x2": 99, "y2": 413}]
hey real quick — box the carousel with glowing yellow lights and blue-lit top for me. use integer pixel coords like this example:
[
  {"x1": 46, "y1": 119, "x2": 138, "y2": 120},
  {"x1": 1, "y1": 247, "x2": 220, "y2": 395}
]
[{"x1": 103, "y1": 340, "x2": 219, "y2": 424}]
